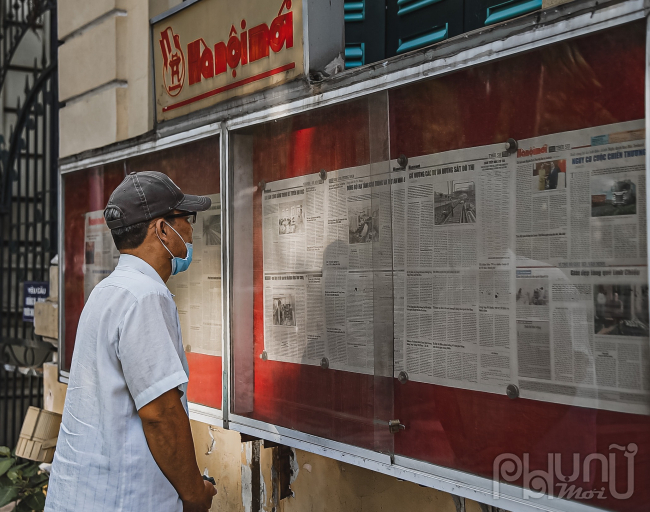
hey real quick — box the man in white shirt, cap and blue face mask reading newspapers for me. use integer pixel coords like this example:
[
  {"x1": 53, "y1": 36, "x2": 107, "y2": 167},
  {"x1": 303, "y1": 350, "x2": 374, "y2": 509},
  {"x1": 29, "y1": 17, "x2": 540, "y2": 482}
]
[{"x1": 45, "y1": 171, "x2": 217, "y2": 512}]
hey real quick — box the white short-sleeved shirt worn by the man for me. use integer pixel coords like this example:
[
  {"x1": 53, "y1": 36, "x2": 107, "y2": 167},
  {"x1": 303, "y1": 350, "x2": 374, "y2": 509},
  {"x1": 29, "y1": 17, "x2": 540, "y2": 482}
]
[{"x1": 45, "y1": 254, "x2": 189, "y2": 512}]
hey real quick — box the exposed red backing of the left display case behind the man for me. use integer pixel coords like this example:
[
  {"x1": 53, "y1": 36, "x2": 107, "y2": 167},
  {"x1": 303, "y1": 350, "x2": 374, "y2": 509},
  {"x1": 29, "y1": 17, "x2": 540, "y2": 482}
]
[{"x1": 62, "y1": 137, "x2": 222, "y2": 409}]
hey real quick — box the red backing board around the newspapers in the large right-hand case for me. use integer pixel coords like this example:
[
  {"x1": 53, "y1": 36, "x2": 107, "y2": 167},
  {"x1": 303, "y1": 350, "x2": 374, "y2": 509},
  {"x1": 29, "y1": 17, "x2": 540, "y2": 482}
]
[{"x1": 233, "y1": 22, "x2": 650, "y2": 512}]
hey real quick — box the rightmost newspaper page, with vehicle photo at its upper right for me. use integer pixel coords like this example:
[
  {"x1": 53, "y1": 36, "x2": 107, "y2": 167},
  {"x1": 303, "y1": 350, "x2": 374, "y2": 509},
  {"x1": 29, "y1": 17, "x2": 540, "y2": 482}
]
[{"x1": 515, "y1": 120, "x2": 650, "y2": 414}]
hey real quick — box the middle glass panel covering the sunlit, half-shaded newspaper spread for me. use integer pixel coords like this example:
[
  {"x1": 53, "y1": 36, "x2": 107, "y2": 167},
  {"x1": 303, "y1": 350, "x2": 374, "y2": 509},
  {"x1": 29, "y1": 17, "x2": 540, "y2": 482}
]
[{"x1": 231, "y1": 94, "x2": 393, "y2": 452}]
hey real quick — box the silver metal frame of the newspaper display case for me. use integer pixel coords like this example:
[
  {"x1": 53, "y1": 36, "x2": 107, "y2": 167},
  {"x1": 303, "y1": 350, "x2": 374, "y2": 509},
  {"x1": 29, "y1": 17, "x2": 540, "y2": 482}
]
[{"x1": 59, "y1": 0, "x2": 650, "y2": 512}]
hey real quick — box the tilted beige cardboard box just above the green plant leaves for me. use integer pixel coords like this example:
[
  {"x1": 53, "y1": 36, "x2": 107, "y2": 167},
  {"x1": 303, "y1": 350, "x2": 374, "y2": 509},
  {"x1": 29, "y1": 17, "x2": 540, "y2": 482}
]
[{"x1": 16, "y1": 407, "x2": 61, "y2": 462}]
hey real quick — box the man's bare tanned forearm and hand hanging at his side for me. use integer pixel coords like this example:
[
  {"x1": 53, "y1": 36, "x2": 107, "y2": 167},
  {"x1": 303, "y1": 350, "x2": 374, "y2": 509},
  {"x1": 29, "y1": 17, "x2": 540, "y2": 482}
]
[{"x1": 138, "y1": 388, "x2": 217, "y2": 512}]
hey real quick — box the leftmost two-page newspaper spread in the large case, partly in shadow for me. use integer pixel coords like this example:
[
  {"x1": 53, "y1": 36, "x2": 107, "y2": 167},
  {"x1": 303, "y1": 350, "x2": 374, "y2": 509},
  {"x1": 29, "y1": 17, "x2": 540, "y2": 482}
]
[{"x1": 262, "y1": 165, "x2": 392, "y2": 374}]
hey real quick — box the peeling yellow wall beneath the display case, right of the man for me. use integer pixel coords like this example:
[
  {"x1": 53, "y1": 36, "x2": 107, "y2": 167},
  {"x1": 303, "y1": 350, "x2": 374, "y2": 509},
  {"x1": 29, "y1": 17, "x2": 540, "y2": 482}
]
[{"x1": 187, "y1": 421, "x2": 480, "y2": 512}]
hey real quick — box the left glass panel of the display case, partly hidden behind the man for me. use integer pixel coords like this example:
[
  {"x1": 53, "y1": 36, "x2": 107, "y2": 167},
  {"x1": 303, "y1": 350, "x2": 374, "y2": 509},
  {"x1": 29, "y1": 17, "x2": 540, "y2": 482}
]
[{"x1": 63, "y1": 136, "x2": 222, "y2": 409}]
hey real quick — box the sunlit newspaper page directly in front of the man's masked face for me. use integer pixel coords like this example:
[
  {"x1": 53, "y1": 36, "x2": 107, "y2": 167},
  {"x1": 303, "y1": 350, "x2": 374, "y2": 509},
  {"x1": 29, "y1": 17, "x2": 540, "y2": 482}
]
[{"x1": 167, "y1": 194, "x2": 222, "y2": 356}]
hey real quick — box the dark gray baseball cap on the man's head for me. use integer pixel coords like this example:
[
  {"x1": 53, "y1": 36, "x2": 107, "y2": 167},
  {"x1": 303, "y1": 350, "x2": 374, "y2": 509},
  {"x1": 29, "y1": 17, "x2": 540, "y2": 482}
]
[{"x1": 104, "y1": 171, "x2": 212, "y2": 229}]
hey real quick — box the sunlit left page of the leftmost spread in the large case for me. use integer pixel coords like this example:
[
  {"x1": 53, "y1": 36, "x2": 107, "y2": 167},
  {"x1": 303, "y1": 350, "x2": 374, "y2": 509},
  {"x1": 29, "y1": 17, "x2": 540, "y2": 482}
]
[{"x1": 262, "y1": 175, "x2": 327, "y2": 365}]
